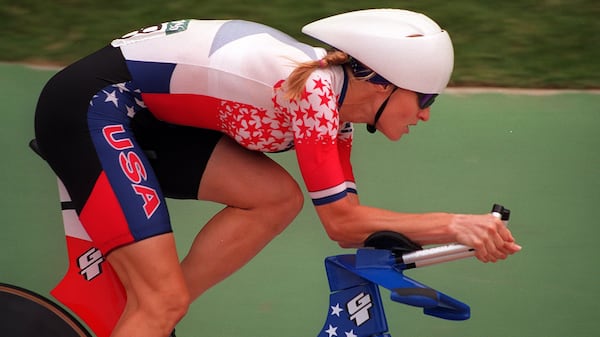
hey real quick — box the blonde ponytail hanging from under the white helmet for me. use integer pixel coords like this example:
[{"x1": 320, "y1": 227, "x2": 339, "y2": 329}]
[{"x1": 285, "y1": 50, "x2": 350, "y2": 99}]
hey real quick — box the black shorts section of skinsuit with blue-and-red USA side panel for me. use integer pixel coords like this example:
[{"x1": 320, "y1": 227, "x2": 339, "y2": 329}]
[{"x1": 35, "y1": 46, "x2": 222, "y2": 253}]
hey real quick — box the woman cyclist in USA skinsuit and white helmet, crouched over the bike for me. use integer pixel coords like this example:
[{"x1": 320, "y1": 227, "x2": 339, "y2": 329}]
[{"x1": 35, "y1": 9, "x2": 520, "y2": 337}]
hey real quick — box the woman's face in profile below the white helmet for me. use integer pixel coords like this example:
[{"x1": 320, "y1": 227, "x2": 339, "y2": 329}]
[{"x1": 376, "y1": 88, "x2": 431, "y2": 141}]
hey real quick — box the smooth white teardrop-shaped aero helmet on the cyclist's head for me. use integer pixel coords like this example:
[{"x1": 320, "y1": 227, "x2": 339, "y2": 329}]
[{"x1": 302, "y1": 9, "x2": 454, "y2": 94}]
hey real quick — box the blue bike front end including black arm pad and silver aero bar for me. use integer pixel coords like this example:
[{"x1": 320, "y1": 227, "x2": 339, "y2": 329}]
[{"x1": 318, "y1": 204, "x2": 510, "y2": 337}]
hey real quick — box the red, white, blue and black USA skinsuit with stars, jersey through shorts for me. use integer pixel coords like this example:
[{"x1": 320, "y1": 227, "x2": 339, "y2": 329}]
[{"x1": 35, "y1": 20, "x2": 356, "y2": 252}]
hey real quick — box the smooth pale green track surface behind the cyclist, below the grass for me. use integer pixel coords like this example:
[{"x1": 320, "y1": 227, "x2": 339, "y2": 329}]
[{"x1": 0, "y1": 64, "x2": 600, "y2": 337}]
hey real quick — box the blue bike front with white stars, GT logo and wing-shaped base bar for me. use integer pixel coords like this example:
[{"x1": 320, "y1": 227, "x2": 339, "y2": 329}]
[{"x1": 318, "y1": 248, "x2": 470, "y2": 337}]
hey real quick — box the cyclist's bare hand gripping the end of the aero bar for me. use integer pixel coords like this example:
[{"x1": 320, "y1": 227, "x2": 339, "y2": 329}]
[{"x1": 450, "y1": 214, "x2": 521, "y2": 262}]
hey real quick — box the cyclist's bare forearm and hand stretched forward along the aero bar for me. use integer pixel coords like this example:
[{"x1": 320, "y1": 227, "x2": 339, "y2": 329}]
[{"x1": 315, "y1": 197, "x2": 521, "y2": 262}]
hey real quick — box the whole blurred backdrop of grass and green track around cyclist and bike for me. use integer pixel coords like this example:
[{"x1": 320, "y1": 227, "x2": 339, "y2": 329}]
[{"x1": 0, "y1": 0, "x2": 600, "y2": 337}]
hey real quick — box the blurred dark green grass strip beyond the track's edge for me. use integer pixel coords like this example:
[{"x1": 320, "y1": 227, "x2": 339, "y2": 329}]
[{"x1": 0, "y1": 0, "x2": 600, "y2": 88}]
